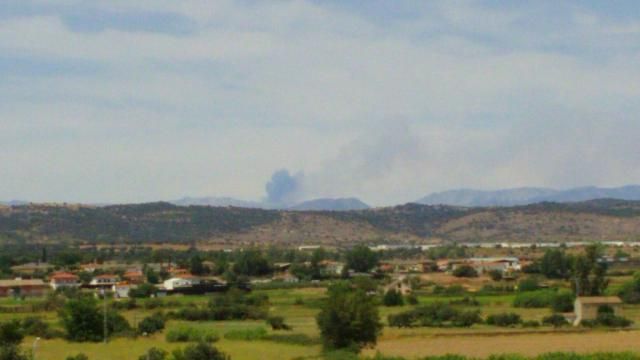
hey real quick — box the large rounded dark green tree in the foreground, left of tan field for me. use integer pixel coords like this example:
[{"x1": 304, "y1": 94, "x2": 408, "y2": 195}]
[{"x1": 316, "y1": 282, "x2": 382, "y2": 350}]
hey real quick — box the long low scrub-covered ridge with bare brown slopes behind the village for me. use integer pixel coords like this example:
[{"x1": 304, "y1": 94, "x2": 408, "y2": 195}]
[{"x1": 0, "y1": 200, "x2": 640, "y2": 245}]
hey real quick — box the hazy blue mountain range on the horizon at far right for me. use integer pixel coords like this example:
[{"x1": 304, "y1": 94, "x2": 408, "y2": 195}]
[{"x1": 417, "y1": 185, "x2": 640, "y2": 207}]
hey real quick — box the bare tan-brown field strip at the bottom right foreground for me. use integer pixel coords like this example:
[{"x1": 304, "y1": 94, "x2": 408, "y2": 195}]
[{"x1": 366, "y1": 331, "x2": 640, "y2": 358}]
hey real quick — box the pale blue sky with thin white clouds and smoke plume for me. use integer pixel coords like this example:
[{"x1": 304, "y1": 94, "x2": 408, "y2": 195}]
[{"x1": 0, "y1": 0, "x2": 640, "y2": 206}]
